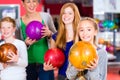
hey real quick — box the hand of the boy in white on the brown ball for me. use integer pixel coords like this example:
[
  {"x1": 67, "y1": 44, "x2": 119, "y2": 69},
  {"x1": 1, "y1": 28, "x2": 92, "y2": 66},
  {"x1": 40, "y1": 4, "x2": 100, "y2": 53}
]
[{"x1": 7, "y1": 50, "x2": 18, "y2": 63}]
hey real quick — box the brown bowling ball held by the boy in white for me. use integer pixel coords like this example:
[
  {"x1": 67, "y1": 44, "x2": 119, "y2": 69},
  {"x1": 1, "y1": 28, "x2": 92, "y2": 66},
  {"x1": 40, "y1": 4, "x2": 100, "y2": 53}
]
[{"x1": 0, "y1": 43, "x2": 17, "y2": 63}]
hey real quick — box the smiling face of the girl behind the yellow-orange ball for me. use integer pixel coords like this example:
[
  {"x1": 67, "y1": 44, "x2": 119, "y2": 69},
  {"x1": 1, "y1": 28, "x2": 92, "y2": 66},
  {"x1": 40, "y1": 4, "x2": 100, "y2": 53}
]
[{"x1": 78, "y1": 20, "x2": 97, "y2": 43}]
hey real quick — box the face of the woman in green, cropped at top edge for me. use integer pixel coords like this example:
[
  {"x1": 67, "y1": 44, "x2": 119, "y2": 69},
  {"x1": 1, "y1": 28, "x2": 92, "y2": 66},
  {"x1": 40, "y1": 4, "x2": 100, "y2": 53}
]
[{"x1": 23, "y1": 0, "x2": 38, "y2": 13}]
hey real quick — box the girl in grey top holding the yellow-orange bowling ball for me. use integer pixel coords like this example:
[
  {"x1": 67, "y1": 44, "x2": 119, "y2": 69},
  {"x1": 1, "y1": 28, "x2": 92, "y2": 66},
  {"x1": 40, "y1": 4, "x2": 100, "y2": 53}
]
[{"x1": 66, "y1": 17, "x2": 108, "y2": 80}]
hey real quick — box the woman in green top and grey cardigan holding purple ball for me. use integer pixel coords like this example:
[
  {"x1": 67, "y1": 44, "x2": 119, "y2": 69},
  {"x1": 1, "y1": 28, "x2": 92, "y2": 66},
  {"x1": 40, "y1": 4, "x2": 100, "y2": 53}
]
[{"x1": 21, "y1": 0, "x2": 56, "y2": 80}]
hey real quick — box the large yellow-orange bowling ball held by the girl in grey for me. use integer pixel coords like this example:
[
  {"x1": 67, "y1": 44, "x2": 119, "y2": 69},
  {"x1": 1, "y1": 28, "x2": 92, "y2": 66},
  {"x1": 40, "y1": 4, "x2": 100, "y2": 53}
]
[{"x1": 69, "y1": 41, "x2": 98, "y2": 70}]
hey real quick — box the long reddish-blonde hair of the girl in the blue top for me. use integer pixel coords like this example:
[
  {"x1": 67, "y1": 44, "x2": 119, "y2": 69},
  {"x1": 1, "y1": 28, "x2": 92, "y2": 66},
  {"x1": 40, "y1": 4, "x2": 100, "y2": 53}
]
[{"x1": 56, "y1": 3, "x2": 81, "y2": 49}]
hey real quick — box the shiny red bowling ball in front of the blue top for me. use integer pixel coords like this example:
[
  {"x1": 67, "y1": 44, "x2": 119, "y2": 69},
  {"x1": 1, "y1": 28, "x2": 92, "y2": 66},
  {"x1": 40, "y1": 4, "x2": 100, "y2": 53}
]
[{"x1": 44, "y1": 48, "x2": 65, "y2": 68}]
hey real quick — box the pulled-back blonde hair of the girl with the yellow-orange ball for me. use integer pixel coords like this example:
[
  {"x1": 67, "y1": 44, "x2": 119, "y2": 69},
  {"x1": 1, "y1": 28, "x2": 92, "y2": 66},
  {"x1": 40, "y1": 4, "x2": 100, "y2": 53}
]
[{"x1": 77, "y1": 17, "x2": 99, "y2": 45}]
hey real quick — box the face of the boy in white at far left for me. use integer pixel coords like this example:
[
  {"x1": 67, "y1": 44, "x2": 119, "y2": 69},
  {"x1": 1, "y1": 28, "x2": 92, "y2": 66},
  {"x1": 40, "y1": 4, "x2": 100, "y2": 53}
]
[{"x1": 1, "y1": 21, "x2": 16, "y2": 38}]
